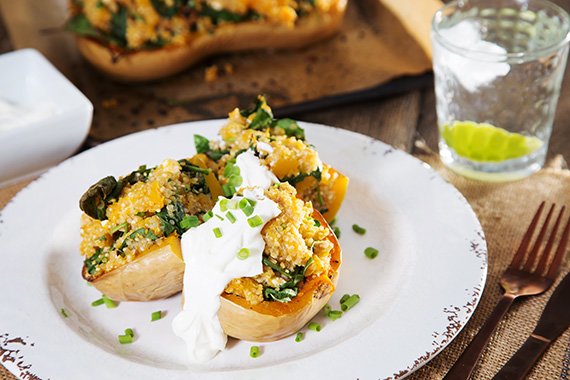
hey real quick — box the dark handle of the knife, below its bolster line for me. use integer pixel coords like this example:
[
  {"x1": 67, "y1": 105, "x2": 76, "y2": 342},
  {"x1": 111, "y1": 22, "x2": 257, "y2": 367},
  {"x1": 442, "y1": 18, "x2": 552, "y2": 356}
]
[{"x1": 493, "y1": 335, "x2": 550, "y2": 380}]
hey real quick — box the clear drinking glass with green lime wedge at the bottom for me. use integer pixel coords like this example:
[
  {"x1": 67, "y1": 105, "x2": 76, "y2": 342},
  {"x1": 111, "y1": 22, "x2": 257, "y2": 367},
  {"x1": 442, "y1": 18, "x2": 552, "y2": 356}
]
[{"x1": 432, "y1": 0, "x2": 570, "y2": 181}]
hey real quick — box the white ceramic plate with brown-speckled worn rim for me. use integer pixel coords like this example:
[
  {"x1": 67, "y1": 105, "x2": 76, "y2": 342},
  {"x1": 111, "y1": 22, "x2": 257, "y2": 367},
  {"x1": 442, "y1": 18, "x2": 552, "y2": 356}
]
[{"x1": 0, "y1": 120, "x2": 487, "y2": 379}]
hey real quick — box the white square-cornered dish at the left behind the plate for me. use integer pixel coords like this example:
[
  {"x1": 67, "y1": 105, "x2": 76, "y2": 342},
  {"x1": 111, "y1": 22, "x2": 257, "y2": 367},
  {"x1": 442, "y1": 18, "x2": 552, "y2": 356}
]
[{"x1": 0, "y1": 49, "x2": 93, "y2": 187}]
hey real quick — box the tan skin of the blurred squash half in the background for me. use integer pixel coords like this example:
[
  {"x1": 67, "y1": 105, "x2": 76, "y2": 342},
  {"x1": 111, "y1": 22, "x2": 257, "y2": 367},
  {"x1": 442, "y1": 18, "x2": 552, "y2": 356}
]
[{"x1": 73, "y1": 0, "x2": 347, "y2": 82}]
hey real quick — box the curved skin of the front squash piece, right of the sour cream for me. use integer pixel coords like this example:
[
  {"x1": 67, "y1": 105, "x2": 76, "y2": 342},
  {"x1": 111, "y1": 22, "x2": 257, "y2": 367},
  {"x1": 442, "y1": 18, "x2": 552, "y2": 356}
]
[{"x1": 218, "y1": 210, "x2": 342, "y2": 342}]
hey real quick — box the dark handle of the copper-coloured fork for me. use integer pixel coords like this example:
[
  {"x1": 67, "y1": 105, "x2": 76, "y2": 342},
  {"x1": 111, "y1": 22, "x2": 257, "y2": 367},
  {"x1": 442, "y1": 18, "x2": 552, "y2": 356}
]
[{"x1": 444, "y1": 293, "x2": 516, "y2": 380}]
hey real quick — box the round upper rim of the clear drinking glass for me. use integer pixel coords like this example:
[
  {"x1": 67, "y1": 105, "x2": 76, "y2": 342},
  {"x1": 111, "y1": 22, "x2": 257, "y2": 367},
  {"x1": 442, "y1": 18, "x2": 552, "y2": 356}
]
[{"x1": 431, "y1": 0, "x2": 570, "y2": 62}]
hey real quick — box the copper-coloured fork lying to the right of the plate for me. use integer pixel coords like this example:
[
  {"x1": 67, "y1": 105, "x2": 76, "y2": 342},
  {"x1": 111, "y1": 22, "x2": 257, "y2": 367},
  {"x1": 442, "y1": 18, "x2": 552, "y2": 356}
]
[{"x1": 444, "y1": 202, "x2": 570, "y2": 380}]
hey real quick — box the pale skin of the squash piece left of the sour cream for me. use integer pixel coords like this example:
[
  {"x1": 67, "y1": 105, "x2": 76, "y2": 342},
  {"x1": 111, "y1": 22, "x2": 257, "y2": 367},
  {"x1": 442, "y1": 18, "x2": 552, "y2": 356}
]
[{"x1": 81, "y1": 235, "x2": 185, "y2": 301}]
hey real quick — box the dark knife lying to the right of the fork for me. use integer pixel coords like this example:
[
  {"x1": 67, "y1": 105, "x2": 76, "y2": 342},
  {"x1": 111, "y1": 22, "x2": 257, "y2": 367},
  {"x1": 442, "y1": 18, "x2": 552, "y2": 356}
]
[{"x1": 493, "y1": 273, "x2": 570, "y2": 380}]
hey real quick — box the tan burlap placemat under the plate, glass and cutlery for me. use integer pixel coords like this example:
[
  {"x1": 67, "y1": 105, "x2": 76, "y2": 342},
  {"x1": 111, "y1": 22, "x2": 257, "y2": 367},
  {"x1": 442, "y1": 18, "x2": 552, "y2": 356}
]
[{"x1": 0, "y1": 150, "x2": 570, "y2": 380}]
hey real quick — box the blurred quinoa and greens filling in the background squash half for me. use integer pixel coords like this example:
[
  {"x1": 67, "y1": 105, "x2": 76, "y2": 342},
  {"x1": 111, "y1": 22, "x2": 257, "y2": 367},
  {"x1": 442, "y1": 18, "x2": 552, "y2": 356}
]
[{"x1": 67, "y1": 0, "x2": 331, "y2": 51}]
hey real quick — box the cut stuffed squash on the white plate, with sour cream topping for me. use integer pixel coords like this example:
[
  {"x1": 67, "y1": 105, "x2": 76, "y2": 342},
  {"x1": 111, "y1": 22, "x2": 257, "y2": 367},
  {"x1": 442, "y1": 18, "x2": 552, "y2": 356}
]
[{"x1": 76, "y1": 97, "x2": 348, "y2": 346}]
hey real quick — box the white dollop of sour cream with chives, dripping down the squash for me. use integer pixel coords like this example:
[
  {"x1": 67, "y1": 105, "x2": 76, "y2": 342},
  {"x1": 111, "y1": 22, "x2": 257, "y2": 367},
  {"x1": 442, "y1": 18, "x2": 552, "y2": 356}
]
[{"x1": 172, "y1": 150, "x2": 281, "y2": 363}]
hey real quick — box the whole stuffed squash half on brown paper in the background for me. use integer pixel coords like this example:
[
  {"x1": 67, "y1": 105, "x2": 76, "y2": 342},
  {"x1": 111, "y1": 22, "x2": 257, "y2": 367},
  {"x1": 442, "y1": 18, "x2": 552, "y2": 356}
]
[{"x1": 67, "y1": 0, "x2": 346, "y2": 81}]
